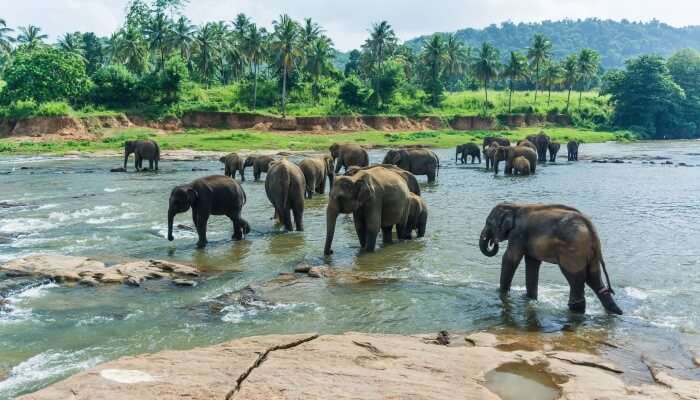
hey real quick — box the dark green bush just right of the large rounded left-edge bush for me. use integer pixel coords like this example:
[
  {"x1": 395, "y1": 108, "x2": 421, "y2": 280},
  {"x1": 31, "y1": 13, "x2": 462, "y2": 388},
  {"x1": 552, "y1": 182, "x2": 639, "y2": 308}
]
[{"x1": 90, "y1": 64, "x2": 138, "y2": 107}]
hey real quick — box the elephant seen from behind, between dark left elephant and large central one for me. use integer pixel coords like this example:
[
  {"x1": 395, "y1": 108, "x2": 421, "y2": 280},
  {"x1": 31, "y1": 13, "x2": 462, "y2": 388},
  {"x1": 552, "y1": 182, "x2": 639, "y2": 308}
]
[{"x1": 265, "y1": 159, "x2": 306, "y2": 232}]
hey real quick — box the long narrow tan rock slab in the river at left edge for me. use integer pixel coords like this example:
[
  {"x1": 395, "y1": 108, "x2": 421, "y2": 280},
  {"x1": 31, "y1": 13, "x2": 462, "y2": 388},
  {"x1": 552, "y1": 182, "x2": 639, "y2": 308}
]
[{"x1": 0, "y1": 254, "x2": 199, "y2": 286}]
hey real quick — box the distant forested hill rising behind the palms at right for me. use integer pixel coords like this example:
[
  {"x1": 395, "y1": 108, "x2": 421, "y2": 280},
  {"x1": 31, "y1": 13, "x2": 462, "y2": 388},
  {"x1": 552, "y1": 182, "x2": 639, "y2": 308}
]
[{"x1": 340, "y1": 19, "x2": 700, "y2": 68}]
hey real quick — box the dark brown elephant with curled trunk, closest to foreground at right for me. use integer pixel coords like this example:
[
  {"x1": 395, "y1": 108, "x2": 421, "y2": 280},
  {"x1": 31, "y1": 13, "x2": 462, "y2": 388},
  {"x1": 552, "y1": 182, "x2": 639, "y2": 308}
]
[{"x1": 479, "y1": 203, "x2": 622, "y2": 315}]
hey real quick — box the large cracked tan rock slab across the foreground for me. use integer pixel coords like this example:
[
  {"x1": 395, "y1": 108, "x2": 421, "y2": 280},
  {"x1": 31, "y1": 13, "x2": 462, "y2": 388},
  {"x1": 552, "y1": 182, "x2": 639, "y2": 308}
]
[{"x1": 20, "y1": 333, "x2": 699, "y2": 400}]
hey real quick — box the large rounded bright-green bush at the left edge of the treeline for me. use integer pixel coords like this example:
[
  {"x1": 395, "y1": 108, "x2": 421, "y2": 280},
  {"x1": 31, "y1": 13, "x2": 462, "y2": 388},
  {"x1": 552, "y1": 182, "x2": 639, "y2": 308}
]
[{"x1": 0, "y1": 46, "x2": 90, "y2": 104}]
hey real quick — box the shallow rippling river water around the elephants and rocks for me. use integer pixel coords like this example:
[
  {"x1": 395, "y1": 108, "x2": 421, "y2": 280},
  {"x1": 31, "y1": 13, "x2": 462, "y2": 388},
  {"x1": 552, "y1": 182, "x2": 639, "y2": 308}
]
[{"x1": 0, "y1": 142, "x2": 700, "y2": 398}]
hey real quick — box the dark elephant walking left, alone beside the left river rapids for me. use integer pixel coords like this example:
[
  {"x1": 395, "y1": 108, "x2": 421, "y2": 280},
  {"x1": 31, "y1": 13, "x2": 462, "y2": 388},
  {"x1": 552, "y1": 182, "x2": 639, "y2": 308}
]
[{"x1": 168, "y1": 175, "x2": 250, "y2": 248}]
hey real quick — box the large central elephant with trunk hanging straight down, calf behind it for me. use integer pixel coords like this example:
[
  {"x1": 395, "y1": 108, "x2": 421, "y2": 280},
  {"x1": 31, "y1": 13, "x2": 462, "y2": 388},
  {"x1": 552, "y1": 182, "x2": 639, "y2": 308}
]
[{"x1": 324, "y1": 167, "x2": 411, "y2": 255}]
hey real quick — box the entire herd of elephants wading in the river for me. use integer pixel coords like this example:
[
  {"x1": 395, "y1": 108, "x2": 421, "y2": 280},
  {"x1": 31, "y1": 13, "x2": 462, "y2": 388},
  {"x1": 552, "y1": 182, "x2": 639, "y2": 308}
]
[{"x1": 125, "y1": 133, "x2": 622, "y2": 314}]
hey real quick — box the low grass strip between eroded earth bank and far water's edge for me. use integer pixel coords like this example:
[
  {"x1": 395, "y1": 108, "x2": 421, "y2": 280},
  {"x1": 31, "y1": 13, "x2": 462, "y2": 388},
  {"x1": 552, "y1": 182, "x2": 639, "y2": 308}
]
[{"x1": 0, "y1": 128, "x2": 631, "y2": 155}]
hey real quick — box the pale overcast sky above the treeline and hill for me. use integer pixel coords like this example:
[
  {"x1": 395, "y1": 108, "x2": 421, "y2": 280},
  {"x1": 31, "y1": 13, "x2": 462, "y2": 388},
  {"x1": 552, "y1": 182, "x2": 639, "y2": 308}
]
[{"x1": 0, "y1": 0, "x2": 700, "y2": 50}]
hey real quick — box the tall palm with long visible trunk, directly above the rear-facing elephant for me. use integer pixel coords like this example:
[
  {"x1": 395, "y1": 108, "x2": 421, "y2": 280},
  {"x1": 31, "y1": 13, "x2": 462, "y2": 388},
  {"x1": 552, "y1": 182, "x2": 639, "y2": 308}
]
[{"x1": 272, "y1": 14, "x2": 300, "y2": 117}]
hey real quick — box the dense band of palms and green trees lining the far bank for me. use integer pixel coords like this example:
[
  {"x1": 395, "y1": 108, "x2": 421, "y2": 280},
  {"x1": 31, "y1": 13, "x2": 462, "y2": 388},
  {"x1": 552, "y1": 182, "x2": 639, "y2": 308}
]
[{"x1": 0, "y1": 0, "x2": 700, "y2": 136}]
